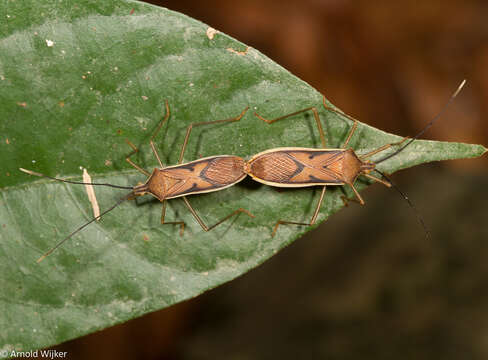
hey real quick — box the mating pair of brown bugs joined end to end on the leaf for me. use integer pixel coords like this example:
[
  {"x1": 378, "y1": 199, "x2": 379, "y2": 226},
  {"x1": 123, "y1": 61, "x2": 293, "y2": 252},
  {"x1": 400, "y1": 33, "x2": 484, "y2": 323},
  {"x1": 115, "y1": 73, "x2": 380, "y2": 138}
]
[{"x1": 20, "y1": 81, "x2": 465, "y2": 262}]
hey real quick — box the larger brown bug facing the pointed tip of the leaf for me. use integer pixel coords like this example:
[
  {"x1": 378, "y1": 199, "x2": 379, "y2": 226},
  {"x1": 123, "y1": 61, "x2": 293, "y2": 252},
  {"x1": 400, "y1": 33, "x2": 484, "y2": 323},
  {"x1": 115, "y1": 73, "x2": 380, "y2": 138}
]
[{"x1": 245, "y1": 81, "x2": 465, "y2": 236}]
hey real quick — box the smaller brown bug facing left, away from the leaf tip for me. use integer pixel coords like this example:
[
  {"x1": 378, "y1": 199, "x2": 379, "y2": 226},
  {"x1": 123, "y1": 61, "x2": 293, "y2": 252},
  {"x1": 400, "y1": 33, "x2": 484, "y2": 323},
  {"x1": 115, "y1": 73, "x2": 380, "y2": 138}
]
[{"x1": 20, "y1": 101, "x2": 254, "y2": 262}]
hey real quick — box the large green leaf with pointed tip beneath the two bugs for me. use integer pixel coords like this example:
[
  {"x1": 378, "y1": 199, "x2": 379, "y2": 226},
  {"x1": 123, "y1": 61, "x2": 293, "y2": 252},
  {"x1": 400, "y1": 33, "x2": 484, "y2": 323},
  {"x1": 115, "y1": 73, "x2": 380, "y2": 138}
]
[{"x1": 0, "y1": 0, "x2": 486, "y2": 351}]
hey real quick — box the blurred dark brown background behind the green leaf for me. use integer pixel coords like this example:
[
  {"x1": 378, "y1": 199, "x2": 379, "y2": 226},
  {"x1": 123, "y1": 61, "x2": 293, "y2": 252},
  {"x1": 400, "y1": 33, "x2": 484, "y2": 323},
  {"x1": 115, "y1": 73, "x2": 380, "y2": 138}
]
[{"x1": 47, "y1": 0, "x2": 488, "y2": 360}]
